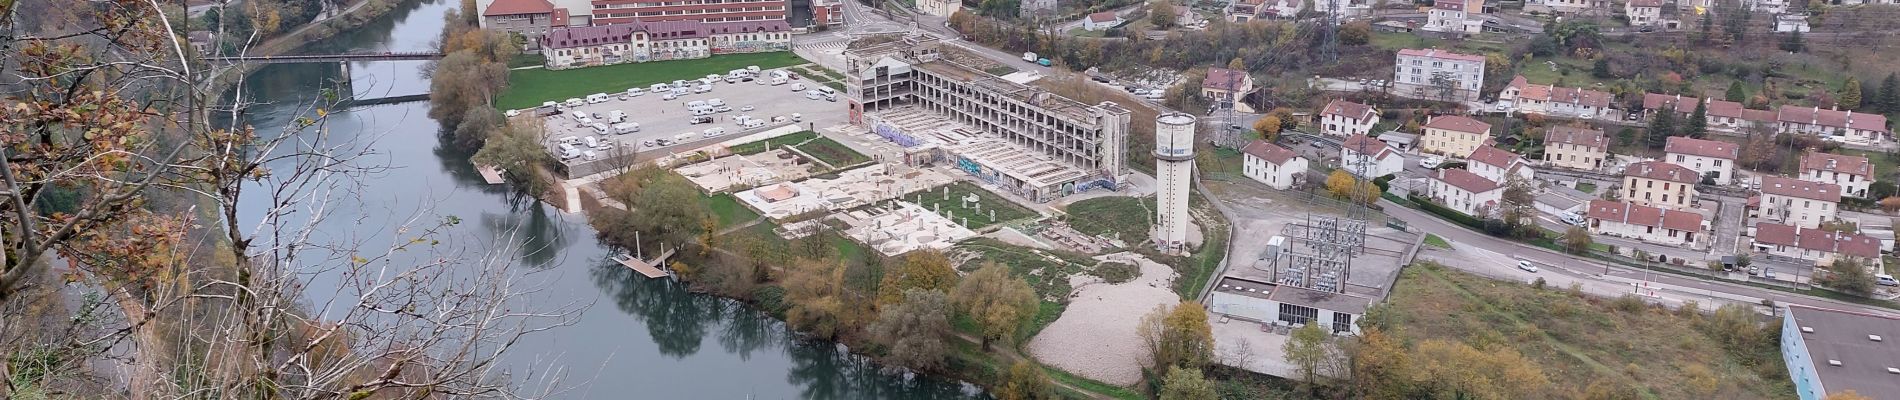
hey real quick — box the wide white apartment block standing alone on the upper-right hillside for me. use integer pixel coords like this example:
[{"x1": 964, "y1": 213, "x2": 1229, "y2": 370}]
[{"x1": 1393, "y1": 49, "x2": 1484, "y2": 102}]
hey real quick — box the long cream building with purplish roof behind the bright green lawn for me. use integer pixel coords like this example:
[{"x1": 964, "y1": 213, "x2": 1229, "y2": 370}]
[{"x1": 542, "y1": 21, "x2": 792, "y2": 70}]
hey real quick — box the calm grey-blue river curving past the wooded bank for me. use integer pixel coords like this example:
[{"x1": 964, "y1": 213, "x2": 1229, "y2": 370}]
[{"x1": 229, "y1": 0, "x2": 984, "y2": 398}]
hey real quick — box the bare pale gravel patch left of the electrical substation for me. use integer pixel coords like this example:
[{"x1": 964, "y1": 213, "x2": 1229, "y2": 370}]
[{"x1": 1030, "y1": 252, "x2": 1180, "y2": 387}]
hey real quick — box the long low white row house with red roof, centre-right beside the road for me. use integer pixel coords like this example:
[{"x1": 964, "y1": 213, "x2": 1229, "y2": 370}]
[{"x1": 1585, "y1": 199, "x2": 1706, "y2": 248}]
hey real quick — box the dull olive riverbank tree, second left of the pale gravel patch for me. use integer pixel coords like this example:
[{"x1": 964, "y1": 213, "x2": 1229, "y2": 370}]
[{"x1": 870, "y1": 288, "x2": 950, "y2": 372}]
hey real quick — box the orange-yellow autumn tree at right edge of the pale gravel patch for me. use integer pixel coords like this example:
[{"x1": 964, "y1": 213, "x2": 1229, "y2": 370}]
[{"x1": 1138, "y1": 301, "x2": 1214, "y2": 370}]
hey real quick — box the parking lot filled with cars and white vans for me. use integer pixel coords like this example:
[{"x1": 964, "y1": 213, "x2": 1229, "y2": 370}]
[{"x1": 545, "y1": 72, "x2": 846, "y2": 157}]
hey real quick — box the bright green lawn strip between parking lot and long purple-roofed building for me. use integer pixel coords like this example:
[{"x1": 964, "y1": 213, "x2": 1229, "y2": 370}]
[{"x1": 494, "y1": 51, "x2": 806, "y2": 110}]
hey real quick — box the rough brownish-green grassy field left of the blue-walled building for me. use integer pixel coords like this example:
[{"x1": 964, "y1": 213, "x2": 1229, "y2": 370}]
[{"x1": 1376, "y1": 264, "x2": 1794, "y2": 398}]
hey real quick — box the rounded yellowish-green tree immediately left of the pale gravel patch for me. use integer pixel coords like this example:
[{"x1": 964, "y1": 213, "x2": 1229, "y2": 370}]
[{"x1": 950, "y1": 262, "x2": 1039, "y2": 349}]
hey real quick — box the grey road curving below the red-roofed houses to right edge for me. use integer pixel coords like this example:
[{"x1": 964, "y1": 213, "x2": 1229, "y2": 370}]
[{"x1": 1379, "y1": 199, "x2": 1900, "y2": 317}]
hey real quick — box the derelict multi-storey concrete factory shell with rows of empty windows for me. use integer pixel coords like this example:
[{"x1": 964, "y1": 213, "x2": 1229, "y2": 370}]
[{"x1": 846, "y1": 36, "x2": 1131, "y2": 201}]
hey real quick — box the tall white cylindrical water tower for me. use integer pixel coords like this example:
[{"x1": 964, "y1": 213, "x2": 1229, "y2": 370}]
[{"x1": 1153, "y1": 112, "x2": 1197, "y2": 252}]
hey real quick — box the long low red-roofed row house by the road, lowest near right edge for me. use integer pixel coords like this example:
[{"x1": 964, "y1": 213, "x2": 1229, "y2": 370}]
[{"x1": 1754, "y1": 222, "x2": 1881, "y2": 265}]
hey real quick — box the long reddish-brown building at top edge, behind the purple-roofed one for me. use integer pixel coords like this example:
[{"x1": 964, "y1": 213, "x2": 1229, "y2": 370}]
[{"x1": 591, "y1": 0, "x2": 790, "y2": 27}]
